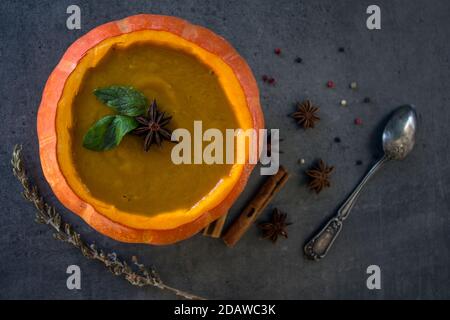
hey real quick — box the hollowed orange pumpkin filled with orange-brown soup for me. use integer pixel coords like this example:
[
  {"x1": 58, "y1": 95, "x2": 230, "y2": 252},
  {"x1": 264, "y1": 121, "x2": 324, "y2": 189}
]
[{"x1": 37, "y1": 15, "x2": 264, "y2": 244}]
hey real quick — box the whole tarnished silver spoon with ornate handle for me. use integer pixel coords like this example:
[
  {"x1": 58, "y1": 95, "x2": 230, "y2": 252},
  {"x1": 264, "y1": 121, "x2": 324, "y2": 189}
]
[{"x1": 304, "y1": 105, "x2": 417, "y2": 260}]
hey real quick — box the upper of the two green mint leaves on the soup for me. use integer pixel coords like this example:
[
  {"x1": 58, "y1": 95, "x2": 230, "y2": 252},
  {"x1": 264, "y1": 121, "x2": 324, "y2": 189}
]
[{"x1": 94, "y1": 86, "x2": 148, "y2": 117}]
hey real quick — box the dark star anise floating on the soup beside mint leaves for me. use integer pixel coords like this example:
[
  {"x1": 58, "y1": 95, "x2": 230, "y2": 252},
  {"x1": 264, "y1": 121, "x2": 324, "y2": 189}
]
[{"x1": 133, "y1": 100, "x2": 172, "y2": 151}]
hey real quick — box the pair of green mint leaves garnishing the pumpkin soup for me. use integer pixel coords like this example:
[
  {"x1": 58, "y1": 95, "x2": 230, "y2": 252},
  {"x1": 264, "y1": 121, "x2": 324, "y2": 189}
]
[{"x1": 83, "y1": 86, "x2": 148, "y2": 151}]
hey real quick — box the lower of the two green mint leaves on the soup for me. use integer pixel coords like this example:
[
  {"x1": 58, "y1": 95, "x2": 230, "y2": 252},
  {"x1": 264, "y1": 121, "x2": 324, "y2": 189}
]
[{"x1": 83, "y1": 115, "x2": 139, "y2": 151}]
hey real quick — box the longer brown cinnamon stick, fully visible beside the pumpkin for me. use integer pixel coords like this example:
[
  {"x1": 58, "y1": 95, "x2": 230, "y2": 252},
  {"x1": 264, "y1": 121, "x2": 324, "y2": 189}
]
[{"x1": 223, "y1": 166, "x2": 289, "y2": 247}]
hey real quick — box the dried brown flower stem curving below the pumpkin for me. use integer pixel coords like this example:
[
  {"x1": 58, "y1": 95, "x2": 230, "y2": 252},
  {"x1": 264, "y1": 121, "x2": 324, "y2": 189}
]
[{"x1": 11, "y1": 145, "x2": 203, "y2": 300}]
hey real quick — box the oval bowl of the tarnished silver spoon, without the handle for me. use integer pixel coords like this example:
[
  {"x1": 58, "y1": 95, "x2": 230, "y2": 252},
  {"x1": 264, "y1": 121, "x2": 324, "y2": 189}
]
[{"x1": 382, "y1": 105, "x2": 417, "y2": 160}]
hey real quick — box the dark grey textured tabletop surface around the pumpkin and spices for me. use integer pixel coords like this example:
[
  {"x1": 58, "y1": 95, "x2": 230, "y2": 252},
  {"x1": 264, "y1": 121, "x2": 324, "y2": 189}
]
[{"x1": 0, "y1": 0, "x2": 450, "y2": 299}]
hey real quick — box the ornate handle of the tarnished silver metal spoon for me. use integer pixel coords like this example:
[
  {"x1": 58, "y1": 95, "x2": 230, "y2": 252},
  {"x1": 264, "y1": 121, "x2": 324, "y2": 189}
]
[{"x1": 304, "y1": 155, "x2": 389, "y2": 260}]
